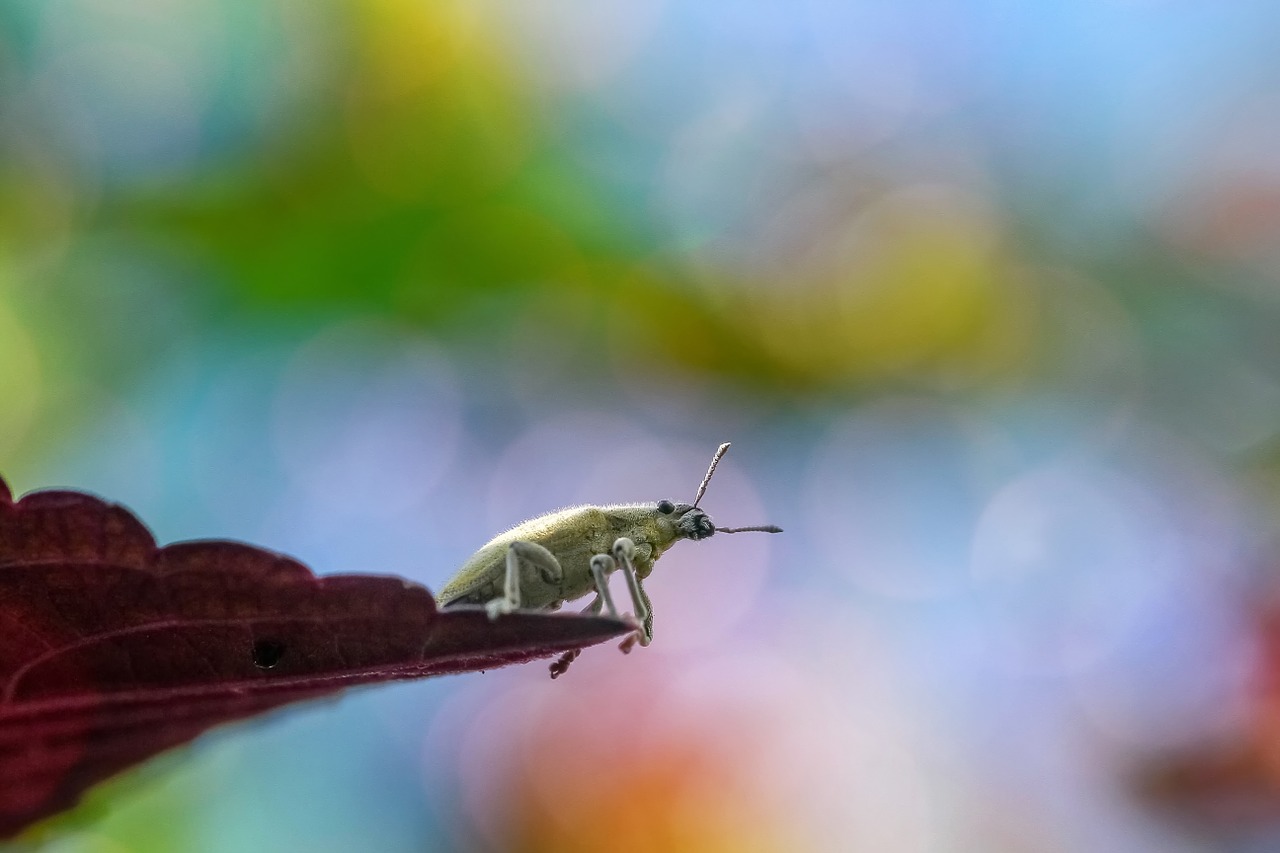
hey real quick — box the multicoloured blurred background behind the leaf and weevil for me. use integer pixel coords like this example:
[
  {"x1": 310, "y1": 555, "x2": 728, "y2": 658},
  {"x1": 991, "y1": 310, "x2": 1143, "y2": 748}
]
[{"x1": 0, "y1": 0, "x2": 1280, "y2": 853}]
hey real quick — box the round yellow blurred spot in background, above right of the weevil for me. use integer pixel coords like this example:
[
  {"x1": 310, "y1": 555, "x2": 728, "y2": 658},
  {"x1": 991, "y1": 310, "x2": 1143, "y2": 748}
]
[{"x1": 745, "y1": 187, "x2": 1024, "y2": 380}]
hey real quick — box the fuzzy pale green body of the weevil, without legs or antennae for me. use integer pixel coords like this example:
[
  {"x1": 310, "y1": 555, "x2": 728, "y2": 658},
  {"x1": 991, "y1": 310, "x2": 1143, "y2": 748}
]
[{"x1": 436, "y1": 503, "x2": 681, "y2": 610}]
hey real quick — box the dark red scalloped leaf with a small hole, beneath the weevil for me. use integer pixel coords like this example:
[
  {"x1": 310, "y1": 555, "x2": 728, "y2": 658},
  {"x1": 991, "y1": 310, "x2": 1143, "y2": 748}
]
[{"x1": 0, "y1": 480, "x2": 630, "y2": 838}]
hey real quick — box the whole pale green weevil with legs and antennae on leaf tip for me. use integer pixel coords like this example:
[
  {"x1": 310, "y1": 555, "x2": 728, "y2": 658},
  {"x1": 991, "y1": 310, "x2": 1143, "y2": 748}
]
[{"x1": 436, "y1": 442, "x2": 782, "y2": 679}]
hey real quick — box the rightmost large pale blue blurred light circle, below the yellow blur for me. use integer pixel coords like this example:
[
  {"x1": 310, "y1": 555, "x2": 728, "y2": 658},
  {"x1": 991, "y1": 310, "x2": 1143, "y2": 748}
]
[{"x1": 972, "y1": 460, "x2": 1181, "y2": 672}]
